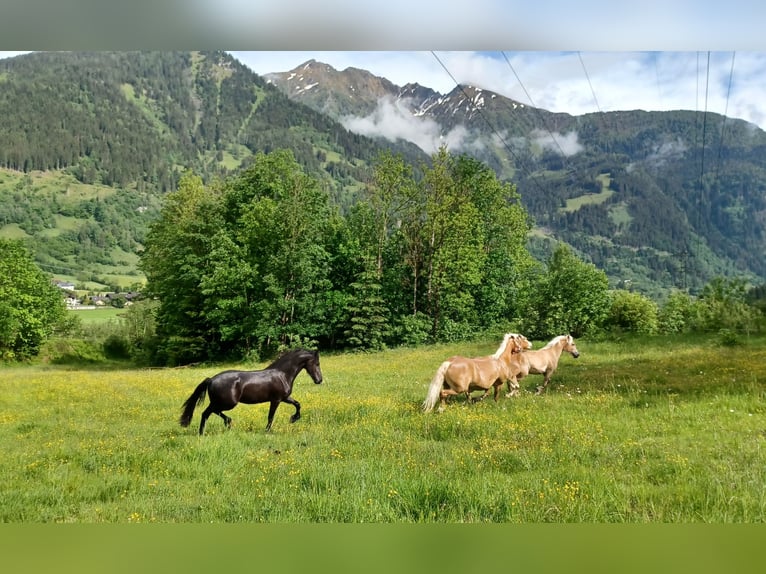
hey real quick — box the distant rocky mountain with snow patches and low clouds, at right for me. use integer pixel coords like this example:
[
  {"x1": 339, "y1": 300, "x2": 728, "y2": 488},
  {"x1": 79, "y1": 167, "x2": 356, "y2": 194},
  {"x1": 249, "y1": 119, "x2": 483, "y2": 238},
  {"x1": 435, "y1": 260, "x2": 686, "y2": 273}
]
[{"x1": 266, "y1": 60, "x2": 766, "y2": 295}]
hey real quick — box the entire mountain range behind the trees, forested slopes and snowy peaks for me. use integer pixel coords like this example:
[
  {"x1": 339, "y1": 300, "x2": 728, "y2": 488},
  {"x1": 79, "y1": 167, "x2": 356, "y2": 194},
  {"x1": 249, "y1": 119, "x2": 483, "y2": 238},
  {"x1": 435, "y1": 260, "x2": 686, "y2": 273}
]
[{"x1": 0, "y1": 52, "x2": 766, "y2": 296}]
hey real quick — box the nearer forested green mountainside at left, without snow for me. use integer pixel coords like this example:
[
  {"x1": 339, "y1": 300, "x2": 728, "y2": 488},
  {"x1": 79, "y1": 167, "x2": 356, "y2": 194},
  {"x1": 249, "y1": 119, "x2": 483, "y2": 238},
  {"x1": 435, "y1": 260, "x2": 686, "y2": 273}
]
[{"x1": 0, "y1": 52, "x2": 428, "y2": 289}]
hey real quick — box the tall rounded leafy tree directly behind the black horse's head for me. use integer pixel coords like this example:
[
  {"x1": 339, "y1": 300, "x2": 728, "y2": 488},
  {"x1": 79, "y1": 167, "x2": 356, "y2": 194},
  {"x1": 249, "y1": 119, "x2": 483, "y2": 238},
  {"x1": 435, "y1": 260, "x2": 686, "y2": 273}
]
[{"x1": 230, "y1": 150, "x2": 333, "y2": 352}]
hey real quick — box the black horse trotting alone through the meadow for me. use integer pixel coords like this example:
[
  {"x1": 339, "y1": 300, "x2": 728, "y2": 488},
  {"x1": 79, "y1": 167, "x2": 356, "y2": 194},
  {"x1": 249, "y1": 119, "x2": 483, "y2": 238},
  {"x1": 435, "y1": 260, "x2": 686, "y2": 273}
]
[{"x1": 179, "y1": 349, "x2": 322, "y2": 434}]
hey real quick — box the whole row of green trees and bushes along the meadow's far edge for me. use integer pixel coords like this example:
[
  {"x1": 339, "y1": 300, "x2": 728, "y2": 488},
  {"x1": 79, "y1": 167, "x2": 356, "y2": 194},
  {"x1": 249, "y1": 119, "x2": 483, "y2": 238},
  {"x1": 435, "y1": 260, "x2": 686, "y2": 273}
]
[{"x1": 0, "y1": 148, "x2": 763, "y2": 365}]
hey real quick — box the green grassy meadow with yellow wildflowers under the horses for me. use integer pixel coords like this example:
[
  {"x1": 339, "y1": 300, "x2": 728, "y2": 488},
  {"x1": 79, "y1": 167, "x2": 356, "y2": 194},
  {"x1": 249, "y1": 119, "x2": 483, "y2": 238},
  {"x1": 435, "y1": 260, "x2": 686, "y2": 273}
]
[{"x1": 0, "y1": 335, "x2": 766, "y2": 523}]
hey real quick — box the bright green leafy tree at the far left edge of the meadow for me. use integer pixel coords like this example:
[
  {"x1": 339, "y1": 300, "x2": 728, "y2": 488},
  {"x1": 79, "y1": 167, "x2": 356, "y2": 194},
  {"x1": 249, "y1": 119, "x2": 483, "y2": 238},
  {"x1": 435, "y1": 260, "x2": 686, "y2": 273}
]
[{"x1": 0, "y1": 239, "x2": 66, "y2": 360}]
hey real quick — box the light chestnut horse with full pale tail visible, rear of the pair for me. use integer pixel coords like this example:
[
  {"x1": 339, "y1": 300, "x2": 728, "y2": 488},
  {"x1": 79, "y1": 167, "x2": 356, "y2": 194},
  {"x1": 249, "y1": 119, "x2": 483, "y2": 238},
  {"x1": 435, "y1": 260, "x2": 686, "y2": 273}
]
[{"x1": 423, "y1": 333, "x2": 532, "y2": 412}]
